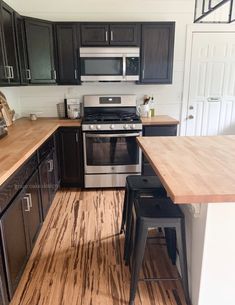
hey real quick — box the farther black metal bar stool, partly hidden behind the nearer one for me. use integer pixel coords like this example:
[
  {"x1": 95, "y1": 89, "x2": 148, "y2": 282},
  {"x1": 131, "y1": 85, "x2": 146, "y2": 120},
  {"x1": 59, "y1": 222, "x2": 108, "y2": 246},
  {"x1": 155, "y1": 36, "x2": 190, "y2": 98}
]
[{"x1": 121, "y1": 175, "x2": 176, "y2": 265}]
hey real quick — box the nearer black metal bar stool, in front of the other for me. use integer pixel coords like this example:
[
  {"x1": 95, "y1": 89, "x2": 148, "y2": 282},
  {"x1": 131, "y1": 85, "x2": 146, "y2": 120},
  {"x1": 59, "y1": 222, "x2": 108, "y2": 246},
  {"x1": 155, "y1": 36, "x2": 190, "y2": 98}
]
[{"x1": 129, "y1": 197, "x2": 190, "y2": 305}]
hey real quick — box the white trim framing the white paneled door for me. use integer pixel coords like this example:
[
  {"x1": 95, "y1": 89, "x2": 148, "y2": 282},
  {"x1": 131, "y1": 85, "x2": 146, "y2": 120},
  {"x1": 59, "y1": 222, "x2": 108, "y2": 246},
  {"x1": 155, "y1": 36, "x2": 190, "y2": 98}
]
[{"x1": 179, "y1": 24, "x2": 235, "y2": 136}]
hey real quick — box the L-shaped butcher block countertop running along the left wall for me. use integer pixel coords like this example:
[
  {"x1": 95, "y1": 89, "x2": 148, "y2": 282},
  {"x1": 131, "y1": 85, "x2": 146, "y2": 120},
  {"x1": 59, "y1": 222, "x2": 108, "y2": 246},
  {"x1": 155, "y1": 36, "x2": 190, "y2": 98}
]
[{"x1": 0, "y1": 118, "x2": 81, "y2": 185}]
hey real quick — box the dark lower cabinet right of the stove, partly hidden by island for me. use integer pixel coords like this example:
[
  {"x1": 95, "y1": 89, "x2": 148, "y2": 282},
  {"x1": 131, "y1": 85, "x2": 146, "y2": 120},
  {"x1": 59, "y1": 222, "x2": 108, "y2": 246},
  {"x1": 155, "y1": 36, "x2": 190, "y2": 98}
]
[{"x1": 142, "y1": 124, "x2": 177, "y2": 176}]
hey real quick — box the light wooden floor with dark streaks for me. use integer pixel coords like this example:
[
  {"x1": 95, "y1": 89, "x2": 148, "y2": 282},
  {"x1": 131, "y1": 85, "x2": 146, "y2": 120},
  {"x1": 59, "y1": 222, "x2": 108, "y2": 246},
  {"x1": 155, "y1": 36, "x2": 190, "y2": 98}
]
[{"x1": 11, "y1": 190, "x2": 185, "y2": 305}]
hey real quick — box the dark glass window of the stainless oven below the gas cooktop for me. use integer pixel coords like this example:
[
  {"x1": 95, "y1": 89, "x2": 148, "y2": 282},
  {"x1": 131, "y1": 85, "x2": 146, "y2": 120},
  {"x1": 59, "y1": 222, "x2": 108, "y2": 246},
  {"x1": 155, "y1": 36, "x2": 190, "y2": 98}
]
[{"x1": 86, "y1": 134, "x2": 139, "y2": 165}]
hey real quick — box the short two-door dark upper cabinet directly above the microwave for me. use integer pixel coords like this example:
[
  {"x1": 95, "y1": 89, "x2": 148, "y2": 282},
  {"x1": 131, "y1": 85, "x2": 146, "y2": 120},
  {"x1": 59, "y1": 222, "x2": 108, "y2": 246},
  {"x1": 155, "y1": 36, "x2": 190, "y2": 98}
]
[{"x1": 81, "y1": 23, "x2": 139, "y2": 46}]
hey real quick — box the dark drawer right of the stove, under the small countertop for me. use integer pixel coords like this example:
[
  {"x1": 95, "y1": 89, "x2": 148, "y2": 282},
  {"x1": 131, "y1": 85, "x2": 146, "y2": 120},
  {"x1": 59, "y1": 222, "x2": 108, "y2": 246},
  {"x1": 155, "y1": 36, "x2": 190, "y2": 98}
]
[{"x1": 143, "y1": 125, "x2": 177, "y2": 137}]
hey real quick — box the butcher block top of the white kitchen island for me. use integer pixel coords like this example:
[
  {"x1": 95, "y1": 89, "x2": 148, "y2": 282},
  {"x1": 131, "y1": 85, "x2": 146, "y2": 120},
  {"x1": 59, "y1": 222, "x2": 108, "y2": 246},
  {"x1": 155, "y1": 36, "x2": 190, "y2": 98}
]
[{"x1": 137, "y1": 136, "x2": 235, "y2": 203}]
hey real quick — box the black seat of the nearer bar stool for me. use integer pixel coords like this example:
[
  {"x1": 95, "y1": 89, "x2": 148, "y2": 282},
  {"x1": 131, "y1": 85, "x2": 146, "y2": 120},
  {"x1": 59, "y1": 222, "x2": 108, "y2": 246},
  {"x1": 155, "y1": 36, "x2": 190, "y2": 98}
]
[{"x1": 135, "y1": 197, "x2": 184, "y2": 220}]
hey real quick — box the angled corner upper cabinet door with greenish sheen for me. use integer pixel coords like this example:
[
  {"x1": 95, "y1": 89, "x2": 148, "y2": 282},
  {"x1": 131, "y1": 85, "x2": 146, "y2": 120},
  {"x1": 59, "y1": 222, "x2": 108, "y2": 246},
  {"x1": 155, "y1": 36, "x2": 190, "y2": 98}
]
[{"x1": 25, "y1": 18, "x2": 56, "y2": 84}]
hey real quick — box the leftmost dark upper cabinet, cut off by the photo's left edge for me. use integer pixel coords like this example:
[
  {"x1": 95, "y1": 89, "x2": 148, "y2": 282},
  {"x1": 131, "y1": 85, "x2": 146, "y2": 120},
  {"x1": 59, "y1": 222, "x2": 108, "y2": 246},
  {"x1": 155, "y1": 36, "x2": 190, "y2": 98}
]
[{"x1": 0, "y1": 1, "x2": 20, "y2": 84}]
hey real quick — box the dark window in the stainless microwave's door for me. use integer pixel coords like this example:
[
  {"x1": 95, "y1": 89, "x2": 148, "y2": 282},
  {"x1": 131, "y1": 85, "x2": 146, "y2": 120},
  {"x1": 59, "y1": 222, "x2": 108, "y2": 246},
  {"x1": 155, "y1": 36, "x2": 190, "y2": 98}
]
[{"x1": 81, "y1": 57, "x2": 122, "y2": 76}]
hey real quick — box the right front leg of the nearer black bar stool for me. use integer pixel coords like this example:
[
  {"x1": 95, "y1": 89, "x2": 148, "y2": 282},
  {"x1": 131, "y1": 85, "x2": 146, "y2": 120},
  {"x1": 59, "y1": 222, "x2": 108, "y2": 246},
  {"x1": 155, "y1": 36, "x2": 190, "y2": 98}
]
[{"x1": 176, "y1": 218, "x2": 191, "y2": 305}]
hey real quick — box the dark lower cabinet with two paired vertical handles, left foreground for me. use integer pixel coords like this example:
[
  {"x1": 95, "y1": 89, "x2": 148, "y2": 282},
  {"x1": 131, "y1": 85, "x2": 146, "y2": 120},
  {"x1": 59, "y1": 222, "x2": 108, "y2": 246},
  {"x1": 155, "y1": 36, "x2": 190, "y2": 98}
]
[{"x1": 0, "y1": 171, "x2": 42, "y2": 298}]
